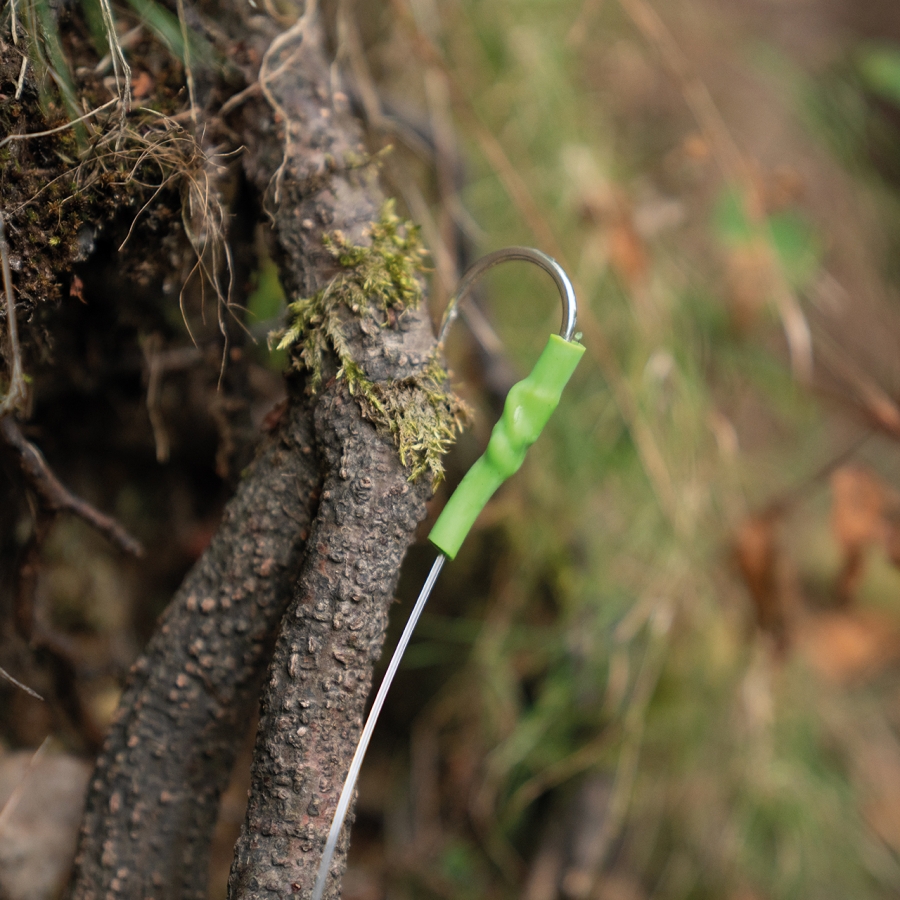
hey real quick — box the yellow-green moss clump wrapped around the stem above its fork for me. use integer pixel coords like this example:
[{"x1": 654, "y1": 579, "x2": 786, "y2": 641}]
[{"x1": 272, "y1": 200, "x2": 466, "y2": 484}]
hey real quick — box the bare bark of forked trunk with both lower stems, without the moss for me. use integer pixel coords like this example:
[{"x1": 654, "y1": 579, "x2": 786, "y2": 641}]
[{"x1": 71, "y1": 4, "x2": 435, "y2": 900}]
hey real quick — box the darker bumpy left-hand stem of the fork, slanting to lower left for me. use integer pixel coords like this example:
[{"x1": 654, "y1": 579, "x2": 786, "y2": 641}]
[{"x1": 71, "y1": 403, "x2": 319, "y2": 900}]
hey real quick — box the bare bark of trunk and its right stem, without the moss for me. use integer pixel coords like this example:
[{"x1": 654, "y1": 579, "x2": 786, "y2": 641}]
[{"x1": 229, "y1": 14, "x2": 434, "y2": 900}]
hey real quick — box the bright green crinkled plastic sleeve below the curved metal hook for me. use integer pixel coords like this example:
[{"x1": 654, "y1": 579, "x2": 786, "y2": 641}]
[{"x1": 428, "y1": 334, "x2": 584, "y2": 559}]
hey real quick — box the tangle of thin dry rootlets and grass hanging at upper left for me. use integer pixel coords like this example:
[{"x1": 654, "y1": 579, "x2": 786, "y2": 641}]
[{"x1": 0, "y1": 0, "x2": 232, "y2": 364}]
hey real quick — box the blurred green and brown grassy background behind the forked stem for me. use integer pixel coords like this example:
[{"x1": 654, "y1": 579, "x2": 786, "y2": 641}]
[{"x1": 8, "y1": 0, "x2": 900, "y2": 900}]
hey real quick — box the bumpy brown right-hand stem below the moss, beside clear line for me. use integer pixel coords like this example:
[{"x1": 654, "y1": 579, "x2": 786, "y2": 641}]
[{"x1": 229, "y1": 356, "x2": 428, "y2": 900}]
